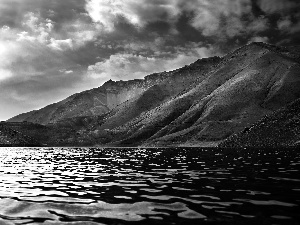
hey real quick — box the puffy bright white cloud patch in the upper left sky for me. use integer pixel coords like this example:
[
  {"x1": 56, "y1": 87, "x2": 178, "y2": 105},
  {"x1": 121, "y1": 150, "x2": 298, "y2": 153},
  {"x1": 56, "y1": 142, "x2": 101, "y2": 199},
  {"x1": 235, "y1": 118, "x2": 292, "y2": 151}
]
[{"x1": 13, "y1": 12, "x2": 101, "y2": 51}]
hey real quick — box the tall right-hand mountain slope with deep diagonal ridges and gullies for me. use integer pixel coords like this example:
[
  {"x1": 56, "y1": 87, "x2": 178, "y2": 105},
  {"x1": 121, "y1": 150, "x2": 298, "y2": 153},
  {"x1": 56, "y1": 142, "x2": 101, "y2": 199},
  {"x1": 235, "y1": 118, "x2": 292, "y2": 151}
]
[{"x1": 99, "y1": 43, "x2": 300, "y2": 146}]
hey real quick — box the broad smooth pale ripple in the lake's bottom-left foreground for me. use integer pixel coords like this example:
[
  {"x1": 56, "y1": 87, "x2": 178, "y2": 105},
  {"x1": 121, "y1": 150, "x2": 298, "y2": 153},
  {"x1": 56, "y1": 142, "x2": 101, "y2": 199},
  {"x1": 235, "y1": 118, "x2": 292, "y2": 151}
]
[{"x1": 0, "y1": 198, "x2": 206, "y2": 223}]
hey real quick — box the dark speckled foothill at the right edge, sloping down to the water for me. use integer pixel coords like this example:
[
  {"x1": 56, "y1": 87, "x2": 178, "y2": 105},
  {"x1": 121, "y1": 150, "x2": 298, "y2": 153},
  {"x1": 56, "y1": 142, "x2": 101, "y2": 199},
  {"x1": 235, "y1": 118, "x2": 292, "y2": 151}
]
[{"x1": 219, "y1": 99, "x2": 300, "y2": 148}]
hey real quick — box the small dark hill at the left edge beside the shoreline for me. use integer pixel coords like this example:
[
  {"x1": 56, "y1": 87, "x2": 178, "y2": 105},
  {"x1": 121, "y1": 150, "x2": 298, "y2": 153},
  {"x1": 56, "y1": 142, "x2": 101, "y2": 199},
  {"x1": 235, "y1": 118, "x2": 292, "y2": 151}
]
[{"x1": 0, "y1": 122, "x2": 41, "y2": 147}]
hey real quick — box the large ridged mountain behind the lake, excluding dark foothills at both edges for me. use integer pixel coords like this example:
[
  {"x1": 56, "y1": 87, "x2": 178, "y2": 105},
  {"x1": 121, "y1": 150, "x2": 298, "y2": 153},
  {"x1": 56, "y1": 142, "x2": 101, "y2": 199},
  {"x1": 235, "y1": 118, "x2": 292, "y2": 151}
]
[{"x1": 5, "y1": 43, "x2": 300, "y2": 146}]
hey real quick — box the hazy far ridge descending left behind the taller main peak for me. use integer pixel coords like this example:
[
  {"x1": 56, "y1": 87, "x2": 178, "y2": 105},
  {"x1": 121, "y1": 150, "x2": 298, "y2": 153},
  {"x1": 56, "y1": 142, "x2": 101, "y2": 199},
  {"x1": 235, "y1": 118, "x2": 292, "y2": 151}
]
[{"x1": 8, "y1": 57, "x2": 220, "y2": 124}]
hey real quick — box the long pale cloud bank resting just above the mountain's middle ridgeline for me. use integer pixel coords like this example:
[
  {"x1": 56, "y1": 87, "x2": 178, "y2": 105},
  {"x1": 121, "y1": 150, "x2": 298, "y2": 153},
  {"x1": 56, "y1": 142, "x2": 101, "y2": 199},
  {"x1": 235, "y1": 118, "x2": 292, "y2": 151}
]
[{"x1": 88, "y1": 43, "x2": 216, "y2": 82}]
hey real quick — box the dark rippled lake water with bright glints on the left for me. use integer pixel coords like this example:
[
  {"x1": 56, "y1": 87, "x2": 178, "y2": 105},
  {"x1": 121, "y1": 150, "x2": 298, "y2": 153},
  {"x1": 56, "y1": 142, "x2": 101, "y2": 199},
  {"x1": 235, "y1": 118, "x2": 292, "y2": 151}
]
[{"x1": 0, "y1": 148, "x2": 300, "y2": 225}]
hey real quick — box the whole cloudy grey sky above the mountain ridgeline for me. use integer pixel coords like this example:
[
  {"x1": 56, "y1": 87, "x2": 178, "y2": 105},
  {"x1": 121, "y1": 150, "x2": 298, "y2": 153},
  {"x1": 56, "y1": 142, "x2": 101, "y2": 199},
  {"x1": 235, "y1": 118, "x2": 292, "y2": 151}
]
[{"x1": 0, "y1": 0, "x2": 300, "y2": 120}]
